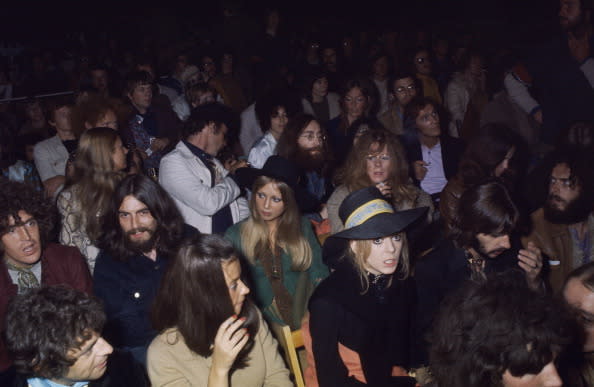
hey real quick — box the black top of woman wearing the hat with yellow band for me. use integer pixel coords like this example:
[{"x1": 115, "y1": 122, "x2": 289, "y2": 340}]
[{"x1": 309, "y1": 264, "x2": 414, "y2": 387}]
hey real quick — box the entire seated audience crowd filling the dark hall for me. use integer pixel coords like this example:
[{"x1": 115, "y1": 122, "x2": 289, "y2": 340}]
[{"x1": 0, "y1": 0, "x2": 594, "y2": 387}]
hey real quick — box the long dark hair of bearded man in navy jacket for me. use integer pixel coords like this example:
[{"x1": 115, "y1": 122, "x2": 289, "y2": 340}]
[{"x1": 98, "y1": 174, "x2": 184, "y2": 260}]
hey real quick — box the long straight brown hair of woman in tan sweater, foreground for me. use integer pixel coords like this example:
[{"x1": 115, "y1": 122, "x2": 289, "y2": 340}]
[{"x1": 152, "y1": 234, "x2": 259, "y2": 369}]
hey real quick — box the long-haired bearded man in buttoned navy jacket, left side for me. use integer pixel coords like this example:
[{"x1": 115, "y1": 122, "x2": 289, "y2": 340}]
[{"x1": 93, "y1": 175, "x2": 196, "y2": 363}]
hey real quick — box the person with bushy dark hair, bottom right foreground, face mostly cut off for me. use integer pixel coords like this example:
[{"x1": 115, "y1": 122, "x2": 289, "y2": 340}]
[{"x1": 431, "y1": 274, "x2": 575, "y2": 387}]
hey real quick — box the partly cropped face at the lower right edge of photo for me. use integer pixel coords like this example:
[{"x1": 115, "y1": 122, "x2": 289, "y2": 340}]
[{"x1": 563, "y1": 278, "x2": 594, "y2": 352}]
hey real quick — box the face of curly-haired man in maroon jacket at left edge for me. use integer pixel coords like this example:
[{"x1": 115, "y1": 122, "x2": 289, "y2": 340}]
[{"x1": 1, "y1": 210, "x2": 42, "y2": 268}]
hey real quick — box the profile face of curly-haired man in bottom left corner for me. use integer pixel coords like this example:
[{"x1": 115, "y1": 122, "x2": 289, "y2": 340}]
[{"x1": 53, "y1": 332, "x2": 113, "y2": 385}]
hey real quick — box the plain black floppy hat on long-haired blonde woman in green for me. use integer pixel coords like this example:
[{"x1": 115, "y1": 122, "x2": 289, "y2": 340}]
[{"x1": 235, "y1": 155, "x2": 318, "y2": 213}]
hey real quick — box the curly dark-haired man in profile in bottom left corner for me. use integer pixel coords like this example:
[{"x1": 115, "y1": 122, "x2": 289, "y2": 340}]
[{"x1": 3, "y1": 286, "x2": 148, "y2": 387}]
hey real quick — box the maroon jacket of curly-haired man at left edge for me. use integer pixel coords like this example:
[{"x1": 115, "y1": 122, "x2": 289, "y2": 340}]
[{"x1": 0, "y1": 243, "x2": 93, "y2": 370}]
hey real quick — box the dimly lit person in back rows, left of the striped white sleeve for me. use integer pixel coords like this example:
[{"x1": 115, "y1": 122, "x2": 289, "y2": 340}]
[{"x1": 444, "y1": 51, "x2": 489, "y2": 140}]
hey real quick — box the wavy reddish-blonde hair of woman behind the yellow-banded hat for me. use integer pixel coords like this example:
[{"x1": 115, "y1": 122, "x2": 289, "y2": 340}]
[{"x1": 336, "y1": 129, "x2": 416, "y2": 208}]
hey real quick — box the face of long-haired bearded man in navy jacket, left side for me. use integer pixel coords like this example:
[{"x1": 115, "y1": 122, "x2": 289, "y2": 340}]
[{"x1": 118, "y1": 195, "x2": 157, "y2": 247}]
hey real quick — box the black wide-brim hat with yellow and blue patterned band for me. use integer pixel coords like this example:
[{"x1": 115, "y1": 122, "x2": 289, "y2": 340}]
[{"x1": 322, "y1": 187, "x2": 427, "y2": 267}]
